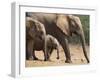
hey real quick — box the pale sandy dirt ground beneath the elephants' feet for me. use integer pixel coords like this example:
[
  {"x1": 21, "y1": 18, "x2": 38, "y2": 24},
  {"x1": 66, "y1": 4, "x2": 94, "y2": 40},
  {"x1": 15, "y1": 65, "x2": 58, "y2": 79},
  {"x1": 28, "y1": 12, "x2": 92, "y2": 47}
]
[{"x1": 25, "y1": 45, "x2": 89, "y2": 67}]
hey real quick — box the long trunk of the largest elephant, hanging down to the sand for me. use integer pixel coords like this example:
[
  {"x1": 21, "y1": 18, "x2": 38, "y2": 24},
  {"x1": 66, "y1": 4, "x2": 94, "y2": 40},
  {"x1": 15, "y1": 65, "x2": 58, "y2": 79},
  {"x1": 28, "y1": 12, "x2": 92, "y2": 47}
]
[{"x1": 80, "y1": 30, "x2": 89, "y2": 63}]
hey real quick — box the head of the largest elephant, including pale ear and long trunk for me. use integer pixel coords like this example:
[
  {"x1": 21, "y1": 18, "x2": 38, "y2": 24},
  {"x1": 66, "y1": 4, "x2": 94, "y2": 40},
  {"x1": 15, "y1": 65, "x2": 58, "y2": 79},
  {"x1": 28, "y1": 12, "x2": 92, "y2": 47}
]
[{"x1": 56, "y1": 15, "x2": 89, "y2": 63}]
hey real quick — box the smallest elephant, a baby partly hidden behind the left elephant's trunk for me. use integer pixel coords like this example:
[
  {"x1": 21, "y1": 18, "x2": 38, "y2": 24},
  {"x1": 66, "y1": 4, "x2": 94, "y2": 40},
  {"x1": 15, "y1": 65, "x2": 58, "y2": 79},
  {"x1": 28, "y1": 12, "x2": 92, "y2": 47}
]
[{"x1": 33, "y1": 34, "x2": 59, "y2": 60}]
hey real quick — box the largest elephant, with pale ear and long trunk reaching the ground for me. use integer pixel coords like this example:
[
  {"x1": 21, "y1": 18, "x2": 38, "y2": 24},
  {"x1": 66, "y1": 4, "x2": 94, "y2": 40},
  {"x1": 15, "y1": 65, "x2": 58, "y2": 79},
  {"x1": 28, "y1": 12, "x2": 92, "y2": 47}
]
[{"x1": 26, "y1": 12, "x2": 89, "y2": 63}]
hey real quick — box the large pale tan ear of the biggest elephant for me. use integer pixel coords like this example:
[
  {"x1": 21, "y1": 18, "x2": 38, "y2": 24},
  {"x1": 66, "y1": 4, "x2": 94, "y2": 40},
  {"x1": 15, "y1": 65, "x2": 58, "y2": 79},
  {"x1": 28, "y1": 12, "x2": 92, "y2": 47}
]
[{"x1": 56, "y1": 15, "x2": 70, "y2": 36}]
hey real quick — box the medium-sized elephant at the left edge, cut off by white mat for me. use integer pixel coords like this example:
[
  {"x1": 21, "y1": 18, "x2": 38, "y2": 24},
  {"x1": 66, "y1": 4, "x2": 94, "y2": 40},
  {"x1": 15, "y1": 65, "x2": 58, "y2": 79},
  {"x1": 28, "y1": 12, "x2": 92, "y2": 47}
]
[{"x1": 26, "y1": 17, "x2": 46, "y2": 60}]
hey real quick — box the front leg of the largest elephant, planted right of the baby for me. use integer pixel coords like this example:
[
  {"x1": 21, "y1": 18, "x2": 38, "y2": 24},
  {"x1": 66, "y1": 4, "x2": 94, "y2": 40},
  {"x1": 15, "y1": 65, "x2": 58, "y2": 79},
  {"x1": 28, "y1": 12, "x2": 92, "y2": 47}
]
[{"x1": 59, "y1": 37, "x2": 72, "y2": 63}]
